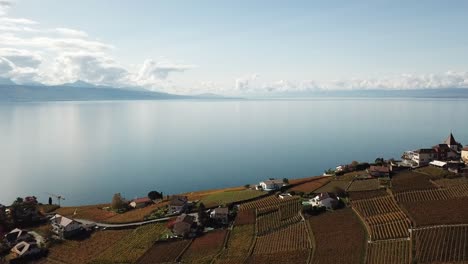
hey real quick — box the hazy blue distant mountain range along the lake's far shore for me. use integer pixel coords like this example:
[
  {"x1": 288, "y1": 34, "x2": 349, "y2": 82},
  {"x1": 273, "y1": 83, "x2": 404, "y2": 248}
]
[{"x1": 0, "y1": 78, "x2": 468, "y2": 102}]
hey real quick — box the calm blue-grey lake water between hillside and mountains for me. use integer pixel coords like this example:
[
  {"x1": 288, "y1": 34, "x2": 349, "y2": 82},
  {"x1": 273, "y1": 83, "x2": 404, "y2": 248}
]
[{"x1": 0, "y1": 99, "x2": 468, "y2": 205}]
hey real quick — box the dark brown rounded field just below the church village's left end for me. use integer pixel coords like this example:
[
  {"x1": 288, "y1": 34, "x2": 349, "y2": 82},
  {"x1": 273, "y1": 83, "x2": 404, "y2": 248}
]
[{"x1": 392, "y1": 171, "x2": 437, "y2": 192}]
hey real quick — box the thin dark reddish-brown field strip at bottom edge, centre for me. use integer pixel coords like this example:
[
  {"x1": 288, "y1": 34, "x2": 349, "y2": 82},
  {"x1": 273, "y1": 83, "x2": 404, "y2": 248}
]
[{"x1": 247, "y1": 250, "x2": 310, "y2": 264}]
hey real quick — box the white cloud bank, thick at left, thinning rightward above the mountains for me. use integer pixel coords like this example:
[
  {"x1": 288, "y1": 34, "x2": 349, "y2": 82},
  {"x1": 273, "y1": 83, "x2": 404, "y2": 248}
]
[{"x1": 0, "y1": 0, "x2": 468, "y2": 95}]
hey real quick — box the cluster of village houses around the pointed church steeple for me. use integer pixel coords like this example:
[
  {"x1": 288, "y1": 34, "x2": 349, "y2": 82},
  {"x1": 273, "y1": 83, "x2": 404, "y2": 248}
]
[{"x1": 402, "y1": 133, "x2": 468, "y2": 172}]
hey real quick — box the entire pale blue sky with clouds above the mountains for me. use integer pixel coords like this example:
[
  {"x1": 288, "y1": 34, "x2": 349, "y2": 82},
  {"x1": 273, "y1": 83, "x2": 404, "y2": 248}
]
[{"x1": 0, "y1": 0, "x2": 468, "y2": 95}]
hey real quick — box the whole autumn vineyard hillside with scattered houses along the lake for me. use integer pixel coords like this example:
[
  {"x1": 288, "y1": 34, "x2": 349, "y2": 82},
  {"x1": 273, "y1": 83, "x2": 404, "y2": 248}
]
[{"x1": 0, "y1": 133, "x2": 468, "y2": 263}]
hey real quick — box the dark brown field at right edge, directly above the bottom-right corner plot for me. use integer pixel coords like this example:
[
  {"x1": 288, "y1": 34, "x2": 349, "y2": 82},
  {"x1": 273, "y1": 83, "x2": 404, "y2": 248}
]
[{"x1": 400, "y1": 197, "x2": 468, "y2": 226}]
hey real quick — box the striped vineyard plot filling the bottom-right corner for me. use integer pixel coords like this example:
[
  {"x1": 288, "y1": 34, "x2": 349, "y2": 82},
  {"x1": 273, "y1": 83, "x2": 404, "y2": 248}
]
[{"x1": 414, "y1": 226, "x2": 468, "y2": 263}]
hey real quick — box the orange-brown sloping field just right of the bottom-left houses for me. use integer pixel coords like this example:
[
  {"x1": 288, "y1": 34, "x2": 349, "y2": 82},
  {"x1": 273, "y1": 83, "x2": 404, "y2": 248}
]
[{"x1": 48, "y1": 230, "x2": 131, "y2": 264}]
